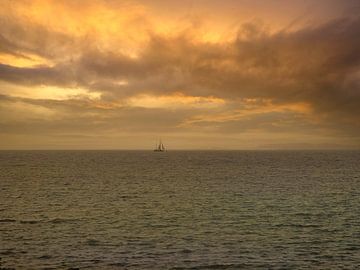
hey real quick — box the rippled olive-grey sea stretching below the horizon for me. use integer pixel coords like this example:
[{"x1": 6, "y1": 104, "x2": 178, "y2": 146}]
[{"x1": 0, "y1": 151, "x2": 360, "y2": 269}]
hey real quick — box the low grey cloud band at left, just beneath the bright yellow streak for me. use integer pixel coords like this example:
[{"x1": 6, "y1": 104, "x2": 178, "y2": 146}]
[{"x1": 0, "y1": 95, "x2": 193, "y2": 135}]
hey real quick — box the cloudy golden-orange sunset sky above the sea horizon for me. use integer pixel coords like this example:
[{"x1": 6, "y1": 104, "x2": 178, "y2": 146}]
[{"x1": 0, "y1": 0, "x2": 360, "y2": 150}]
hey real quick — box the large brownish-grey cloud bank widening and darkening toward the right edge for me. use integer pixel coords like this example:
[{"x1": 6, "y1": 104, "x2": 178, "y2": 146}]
[{"x1": 18, "y1": 15, "x2": 360, "y2": 120}]
